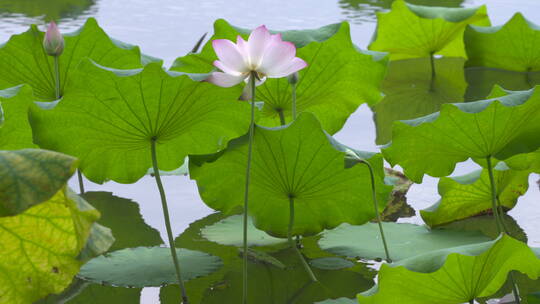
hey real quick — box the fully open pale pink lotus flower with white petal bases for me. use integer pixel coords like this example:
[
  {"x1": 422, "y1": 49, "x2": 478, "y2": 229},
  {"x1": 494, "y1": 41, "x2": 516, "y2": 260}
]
[{"x1": 207, "y1": 25, "x2": 307, "y2": 87}]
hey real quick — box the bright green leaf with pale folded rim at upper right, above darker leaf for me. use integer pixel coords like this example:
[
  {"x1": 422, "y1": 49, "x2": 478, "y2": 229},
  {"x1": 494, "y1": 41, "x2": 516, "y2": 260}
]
[{"x1": 369, "y1": 0, "x2": 490, "y2": 60}]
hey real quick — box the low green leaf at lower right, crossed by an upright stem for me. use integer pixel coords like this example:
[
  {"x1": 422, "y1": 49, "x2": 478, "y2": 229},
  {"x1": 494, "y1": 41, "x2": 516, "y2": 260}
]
[{"x1": 420, "y1": 163, "x2": 529, "y2": 227}]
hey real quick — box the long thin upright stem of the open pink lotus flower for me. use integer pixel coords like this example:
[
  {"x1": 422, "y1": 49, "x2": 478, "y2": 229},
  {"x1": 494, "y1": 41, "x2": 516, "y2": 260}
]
[{"x1": 242, "y1": 72, "x2": 257, "y2": 304}]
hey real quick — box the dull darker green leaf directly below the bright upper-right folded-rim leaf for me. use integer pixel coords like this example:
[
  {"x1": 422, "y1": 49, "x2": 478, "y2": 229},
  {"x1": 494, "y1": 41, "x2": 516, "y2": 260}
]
[{"x1": 372, "y1": 58, "x2": 467, "y2": 145}]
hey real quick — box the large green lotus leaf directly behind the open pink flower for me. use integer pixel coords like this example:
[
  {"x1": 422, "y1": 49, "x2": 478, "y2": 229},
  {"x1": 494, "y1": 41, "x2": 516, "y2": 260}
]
[{"x1": 172, "y1": 20, "x2": 386, "y2": 134}]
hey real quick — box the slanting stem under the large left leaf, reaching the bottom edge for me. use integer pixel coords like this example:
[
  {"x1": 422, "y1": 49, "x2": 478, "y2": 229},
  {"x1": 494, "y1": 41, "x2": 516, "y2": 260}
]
[{"x1": 150, "y1": 138, "x2": 189, "y2": 304}]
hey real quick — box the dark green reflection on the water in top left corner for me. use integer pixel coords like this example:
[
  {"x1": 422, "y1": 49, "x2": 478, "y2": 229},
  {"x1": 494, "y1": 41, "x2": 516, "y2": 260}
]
[{"x1": 0, "y1": 0, "x2": 96, "y2": 21}]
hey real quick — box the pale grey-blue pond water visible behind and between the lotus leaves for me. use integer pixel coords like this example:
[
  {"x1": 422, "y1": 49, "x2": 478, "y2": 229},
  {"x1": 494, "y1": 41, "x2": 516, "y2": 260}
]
[{"x1": 0, "y1": 0, "x2": 540, "y2": 303}]
